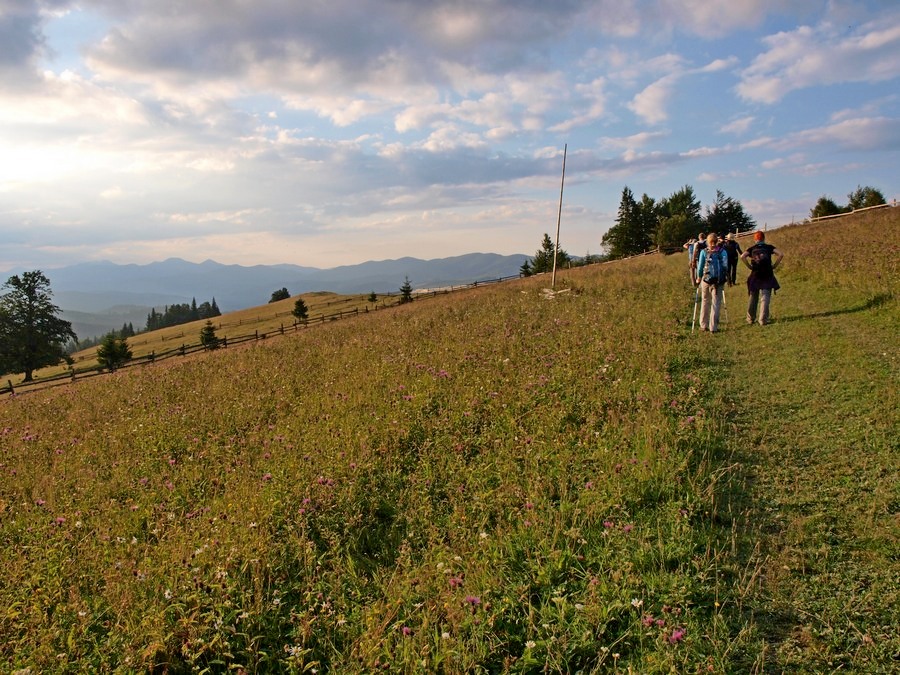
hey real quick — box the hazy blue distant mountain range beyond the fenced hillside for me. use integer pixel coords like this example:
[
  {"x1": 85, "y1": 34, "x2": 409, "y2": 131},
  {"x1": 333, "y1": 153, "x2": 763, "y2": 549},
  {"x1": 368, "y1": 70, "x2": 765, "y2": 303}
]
[{"x1": 35, "y1": 253, "x2": 531, "y2": 339}]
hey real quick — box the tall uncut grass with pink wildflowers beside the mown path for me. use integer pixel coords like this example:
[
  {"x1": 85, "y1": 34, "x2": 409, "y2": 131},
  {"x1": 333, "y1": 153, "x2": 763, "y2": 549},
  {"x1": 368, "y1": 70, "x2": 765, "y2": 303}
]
[{"x1": 0, "y1": 209, "x2": 896, "y2": 673}]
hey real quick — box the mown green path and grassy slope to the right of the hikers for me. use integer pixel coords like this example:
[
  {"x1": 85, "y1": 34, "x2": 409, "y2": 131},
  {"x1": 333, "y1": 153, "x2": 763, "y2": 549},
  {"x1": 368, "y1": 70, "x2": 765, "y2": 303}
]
[{"x1": 704, "y1": 209, "x2": 900, "y2": 672}]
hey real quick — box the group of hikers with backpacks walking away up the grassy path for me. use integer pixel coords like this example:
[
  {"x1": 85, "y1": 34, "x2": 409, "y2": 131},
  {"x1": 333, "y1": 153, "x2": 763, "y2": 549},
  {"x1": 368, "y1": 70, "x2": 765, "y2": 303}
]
[{"x1": 684, "y1": 230, "x2": 784, "y2": 333}]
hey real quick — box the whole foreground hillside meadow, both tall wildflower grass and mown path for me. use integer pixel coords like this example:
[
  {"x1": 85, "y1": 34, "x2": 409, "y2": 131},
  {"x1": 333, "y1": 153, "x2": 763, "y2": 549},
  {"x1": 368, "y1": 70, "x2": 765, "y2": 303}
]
[{"x1": 0, "y1": 208, "x2": 900, "y2": 673}]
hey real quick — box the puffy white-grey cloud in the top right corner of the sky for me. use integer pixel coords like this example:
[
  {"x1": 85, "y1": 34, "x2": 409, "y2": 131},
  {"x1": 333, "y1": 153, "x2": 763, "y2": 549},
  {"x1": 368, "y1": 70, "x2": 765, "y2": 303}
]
[{"x1": 736, "y1": 11, "x2": 900, "y2": 104}]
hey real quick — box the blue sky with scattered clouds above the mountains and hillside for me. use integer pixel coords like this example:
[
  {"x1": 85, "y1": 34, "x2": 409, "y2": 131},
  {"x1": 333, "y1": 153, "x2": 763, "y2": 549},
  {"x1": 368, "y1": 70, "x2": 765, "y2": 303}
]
[{"x1": 0, "y1": 0, "x2": 900, "y2": 271}]
